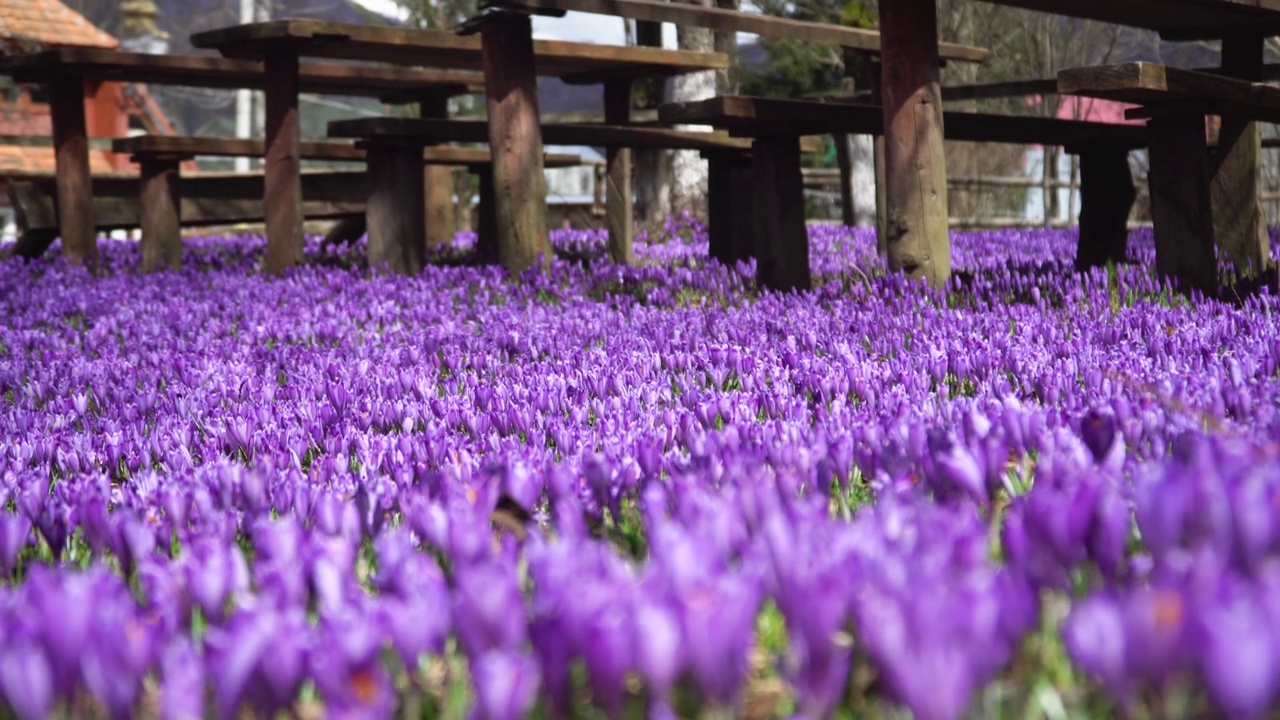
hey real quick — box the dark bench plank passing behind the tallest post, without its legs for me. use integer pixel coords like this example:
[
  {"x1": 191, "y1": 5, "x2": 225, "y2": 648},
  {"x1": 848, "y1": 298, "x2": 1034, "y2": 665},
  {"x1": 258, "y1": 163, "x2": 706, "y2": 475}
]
[{"x1": 658, "y1": 95, "x2": 1147, "y2": 147}]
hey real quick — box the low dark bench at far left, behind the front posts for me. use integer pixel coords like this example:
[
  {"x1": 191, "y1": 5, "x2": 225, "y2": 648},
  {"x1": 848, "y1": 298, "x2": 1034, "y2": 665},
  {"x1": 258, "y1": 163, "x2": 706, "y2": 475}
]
[{"x1": 5, "y1": 170, "x2": 365, "y2": 261}]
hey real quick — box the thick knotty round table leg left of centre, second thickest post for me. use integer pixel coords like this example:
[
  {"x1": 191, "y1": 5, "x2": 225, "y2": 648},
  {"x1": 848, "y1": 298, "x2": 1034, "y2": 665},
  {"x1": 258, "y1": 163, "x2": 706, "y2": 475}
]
[{"x1": 480, "y1": 13, "x2": 552, "y2": 273}]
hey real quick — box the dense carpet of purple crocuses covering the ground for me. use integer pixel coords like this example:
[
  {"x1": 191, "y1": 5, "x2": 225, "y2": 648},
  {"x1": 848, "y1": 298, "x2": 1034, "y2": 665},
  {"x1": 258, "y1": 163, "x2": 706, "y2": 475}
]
[{"x1": 0, "y1": 219, "x2": 1280, "y2": 720}]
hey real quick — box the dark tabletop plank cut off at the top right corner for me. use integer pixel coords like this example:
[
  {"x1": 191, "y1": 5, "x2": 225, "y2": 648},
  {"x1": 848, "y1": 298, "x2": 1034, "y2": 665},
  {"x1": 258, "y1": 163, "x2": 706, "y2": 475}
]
[{"x1": 988, "y1": 0, "x2": 1280, "y2": 40}]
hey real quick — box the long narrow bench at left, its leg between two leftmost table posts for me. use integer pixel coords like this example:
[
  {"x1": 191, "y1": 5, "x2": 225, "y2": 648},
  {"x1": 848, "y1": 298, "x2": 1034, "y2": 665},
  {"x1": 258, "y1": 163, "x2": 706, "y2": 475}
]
[{"x1": 113, "y1": 135, "x2": 582, "y2": 272}]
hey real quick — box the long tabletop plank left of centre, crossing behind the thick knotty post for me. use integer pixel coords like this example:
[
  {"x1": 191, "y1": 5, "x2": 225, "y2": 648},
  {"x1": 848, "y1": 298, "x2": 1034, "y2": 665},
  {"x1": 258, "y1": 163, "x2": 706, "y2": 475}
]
[{"x1": 191, "y1": 19, "x2": 730, "y2": 82}]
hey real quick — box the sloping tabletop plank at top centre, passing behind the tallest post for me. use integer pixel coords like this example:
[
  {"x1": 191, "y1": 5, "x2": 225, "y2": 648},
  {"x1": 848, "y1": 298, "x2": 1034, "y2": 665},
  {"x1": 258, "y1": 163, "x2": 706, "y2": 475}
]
[{"x1": 488, "y1": 0, "x2": 989, "y2": 63}]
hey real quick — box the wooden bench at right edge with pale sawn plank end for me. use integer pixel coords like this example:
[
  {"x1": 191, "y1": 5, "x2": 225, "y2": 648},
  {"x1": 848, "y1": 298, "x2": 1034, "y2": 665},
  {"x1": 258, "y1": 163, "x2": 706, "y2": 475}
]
[{"x1": 1059, "y1": 63, "x2": 1280, "y2": 295}]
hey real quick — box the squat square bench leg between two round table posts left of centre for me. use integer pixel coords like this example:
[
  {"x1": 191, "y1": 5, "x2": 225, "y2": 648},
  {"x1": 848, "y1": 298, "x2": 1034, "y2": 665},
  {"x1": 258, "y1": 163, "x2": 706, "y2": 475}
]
[{"x1": 365, "y1": 142, "x2": 426, "y2": 275}]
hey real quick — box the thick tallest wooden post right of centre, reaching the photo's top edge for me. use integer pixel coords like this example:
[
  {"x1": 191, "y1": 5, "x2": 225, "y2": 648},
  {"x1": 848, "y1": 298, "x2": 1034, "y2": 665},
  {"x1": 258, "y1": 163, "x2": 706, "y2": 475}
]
[{"x1": 879, "y1": 0, "x2": 951, "y2": 286}]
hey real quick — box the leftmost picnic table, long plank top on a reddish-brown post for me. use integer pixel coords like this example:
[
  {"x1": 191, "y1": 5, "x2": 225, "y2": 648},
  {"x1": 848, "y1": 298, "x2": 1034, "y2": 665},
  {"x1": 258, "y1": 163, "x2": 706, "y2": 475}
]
[{"x1": 0, "y1": 49, "x2": 484, "y2": 265}]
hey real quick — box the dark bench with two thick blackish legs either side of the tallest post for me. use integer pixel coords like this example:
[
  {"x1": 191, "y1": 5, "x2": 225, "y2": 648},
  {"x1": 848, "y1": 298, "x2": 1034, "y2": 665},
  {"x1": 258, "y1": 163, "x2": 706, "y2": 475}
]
[{"x1": 658, "y1": 96, "x2": 1147, "y2": 290}]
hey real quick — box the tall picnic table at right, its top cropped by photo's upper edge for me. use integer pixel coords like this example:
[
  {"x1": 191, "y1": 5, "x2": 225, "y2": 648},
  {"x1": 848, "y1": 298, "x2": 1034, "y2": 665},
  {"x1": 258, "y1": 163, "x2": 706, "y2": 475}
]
[{"x1": 879, "y1": 0, "x2": 1280, "y2": 284}]
